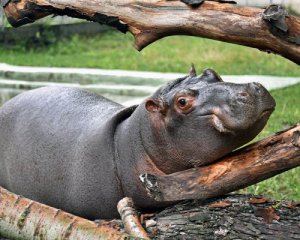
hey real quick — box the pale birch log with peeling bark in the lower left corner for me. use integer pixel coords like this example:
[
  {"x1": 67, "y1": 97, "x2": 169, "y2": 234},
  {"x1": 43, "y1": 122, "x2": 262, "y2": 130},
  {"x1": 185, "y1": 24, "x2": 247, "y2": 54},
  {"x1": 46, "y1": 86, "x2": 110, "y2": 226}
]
[{"x1": 0, "y1": 187, "x2": 128, "y2": 240}]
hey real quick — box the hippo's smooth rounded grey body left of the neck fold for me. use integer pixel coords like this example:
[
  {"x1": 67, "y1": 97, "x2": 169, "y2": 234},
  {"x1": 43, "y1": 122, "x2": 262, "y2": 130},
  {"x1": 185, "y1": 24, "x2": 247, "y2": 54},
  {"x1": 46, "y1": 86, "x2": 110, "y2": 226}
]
[{"x1": 0, "y1": 87, "x2": 134, "y2": 218}]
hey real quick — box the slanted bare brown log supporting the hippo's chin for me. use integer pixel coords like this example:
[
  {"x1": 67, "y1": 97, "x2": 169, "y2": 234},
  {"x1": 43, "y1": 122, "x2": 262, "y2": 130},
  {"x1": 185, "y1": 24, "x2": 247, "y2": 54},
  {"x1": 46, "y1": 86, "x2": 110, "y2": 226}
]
[{"x1": 140, "y1": 124, "x2": 300, "y2": 201}]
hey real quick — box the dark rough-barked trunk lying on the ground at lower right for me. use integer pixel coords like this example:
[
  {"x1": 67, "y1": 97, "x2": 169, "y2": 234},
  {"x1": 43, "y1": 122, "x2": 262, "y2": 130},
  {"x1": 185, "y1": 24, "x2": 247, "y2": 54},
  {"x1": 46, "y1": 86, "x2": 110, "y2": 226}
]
[{"x1": 144, "y1": 195, "x2": 300, "y2": 240}]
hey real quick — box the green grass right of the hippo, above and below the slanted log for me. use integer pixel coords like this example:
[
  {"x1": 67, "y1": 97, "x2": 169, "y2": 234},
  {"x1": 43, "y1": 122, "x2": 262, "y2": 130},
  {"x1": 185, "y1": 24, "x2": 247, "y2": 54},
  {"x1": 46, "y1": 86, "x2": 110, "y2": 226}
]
[{"x1": 242, "y1": 84, "x2": 300, "y2": 201}]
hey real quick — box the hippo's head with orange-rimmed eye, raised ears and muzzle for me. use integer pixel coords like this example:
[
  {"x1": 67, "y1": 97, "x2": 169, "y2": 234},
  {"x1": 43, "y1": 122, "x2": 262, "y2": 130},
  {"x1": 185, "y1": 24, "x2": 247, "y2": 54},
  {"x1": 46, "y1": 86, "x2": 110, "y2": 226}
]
[{"x1": 144, "y1": 67, "x2": 275, "y2": 173}]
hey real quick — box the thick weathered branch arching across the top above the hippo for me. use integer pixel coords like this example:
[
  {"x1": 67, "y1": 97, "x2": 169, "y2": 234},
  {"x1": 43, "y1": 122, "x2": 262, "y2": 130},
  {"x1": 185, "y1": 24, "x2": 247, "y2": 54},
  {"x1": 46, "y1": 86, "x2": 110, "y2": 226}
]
[{"x1": 1, "y1": 0, "x2": 300, "y2": 64}]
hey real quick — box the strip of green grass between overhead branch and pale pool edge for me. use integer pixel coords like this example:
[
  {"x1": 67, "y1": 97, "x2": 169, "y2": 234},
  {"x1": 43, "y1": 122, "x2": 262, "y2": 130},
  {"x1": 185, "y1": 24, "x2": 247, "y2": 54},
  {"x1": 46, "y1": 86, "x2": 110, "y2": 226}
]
[{"x1": 0, "y1": 31, "x2": 300, "y2": 76}]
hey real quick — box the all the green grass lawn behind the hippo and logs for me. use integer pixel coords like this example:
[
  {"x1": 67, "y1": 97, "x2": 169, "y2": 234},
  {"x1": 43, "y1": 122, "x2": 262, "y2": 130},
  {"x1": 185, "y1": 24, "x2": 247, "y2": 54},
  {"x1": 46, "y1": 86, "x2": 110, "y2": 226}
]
[{"x1": 0, "y1": 32, "x2": 300, "y2": 201}]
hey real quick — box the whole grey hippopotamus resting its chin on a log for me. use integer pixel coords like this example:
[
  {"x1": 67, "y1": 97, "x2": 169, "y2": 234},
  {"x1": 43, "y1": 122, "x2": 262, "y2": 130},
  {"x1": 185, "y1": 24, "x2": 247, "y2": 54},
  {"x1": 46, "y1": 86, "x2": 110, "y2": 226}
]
[{"x1": 0, "y1": 66, "x2": 275, "y2": 219}]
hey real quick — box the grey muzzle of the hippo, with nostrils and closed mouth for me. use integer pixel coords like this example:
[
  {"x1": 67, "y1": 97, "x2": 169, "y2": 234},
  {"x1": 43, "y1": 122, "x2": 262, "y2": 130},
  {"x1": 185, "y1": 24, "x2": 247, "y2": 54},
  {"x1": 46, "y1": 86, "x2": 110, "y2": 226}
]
[{"x1": 210, "y1": 82, "x2": 276, "y2": 133}]
